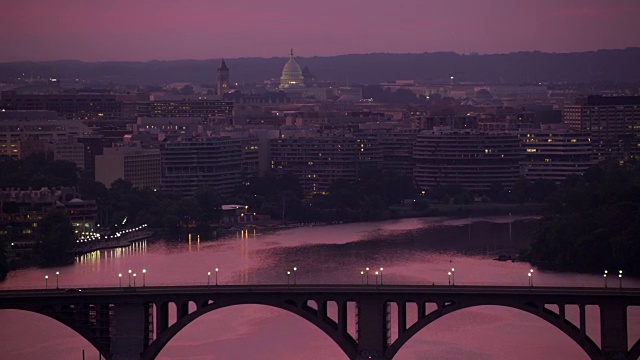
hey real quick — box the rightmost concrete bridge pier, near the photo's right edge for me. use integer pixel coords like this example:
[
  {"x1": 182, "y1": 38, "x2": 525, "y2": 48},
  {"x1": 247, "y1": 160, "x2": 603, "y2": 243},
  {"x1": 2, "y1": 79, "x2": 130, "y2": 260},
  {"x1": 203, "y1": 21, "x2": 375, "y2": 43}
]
[{"x1": 600, "y1": 301, "x2": 635, "y2": 360}]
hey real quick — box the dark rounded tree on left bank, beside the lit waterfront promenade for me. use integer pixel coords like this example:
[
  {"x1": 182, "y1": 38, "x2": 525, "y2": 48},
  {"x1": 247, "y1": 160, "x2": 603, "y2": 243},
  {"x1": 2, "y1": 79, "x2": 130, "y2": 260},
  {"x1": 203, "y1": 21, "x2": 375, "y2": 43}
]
[{"x1": 36, "y1": 210, "x2": 76, "y2": 266}]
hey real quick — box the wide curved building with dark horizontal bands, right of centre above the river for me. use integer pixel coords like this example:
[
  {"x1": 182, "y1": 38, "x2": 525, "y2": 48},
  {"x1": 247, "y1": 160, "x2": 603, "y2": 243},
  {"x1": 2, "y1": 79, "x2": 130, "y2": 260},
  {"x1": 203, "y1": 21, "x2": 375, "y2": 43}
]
[{"x1": 413, "y1": 127, "x2": 524, "y2": 193}]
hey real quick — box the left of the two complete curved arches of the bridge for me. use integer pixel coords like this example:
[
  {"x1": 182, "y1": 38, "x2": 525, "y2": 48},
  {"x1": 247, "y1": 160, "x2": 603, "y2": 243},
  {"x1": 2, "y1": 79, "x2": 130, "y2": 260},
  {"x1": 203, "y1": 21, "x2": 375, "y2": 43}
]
[{"x1": 140, "y1": 300, "x2": 357, "y2": 360}]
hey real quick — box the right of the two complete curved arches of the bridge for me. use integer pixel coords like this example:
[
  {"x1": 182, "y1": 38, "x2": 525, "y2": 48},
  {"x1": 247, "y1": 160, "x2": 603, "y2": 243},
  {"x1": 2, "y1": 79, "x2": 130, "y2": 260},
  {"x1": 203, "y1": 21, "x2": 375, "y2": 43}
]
[{"x1": 385, "y1": 301, "x2": 600, "y2": 359}]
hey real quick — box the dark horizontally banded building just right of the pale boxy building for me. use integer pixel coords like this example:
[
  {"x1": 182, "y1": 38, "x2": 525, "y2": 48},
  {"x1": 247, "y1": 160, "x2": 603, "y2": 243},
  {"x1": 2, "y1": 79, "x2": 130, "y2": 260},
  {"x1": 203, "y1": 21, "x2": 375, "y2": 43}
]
[{"x1": 161, "y1": 135, "x2": 243, "y2": 198}]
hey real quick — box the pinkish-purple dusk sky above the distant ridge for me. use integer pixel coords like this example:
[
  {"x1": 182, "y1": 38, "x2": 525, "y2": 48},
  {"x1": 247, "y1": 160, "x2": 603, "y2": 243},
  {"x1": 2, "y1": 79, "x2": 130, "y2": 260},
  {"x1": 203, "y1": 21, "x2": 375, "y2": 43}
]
[{"x1": 0, "y1": 0, "x2": 640, "y2": 61}]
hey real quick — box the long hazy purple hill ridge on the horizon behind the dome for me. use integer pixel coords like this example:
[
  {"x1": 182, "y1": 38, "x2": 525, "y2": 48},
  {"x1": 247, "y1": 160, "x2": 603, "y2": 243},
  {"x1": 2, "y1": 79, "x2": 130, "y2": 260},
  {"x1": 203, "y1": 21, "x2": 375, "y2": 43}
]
[{"x1": 0, "y1": 48, "x2": 640, "y2": 85}]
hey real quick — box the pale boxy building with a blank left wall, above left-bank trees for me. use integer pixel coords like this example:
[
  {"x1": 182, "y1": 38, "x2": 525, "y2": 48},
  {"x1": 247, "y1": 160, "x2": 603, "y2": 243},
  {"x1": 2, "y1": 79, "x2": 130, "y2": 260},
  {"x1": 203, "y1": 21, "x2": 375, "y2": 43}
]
[{"x1": 95, "y1": 143, "x2": 162, "y2": 189}]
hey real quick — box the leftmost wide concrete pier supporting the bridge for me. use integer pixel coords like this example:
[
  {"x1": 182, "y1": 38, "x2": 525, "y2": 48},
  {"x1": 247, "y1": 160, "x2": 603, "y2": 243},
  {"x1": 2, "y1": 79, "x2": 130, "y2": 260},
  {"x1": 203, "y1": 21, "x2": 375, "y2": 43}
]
[{"x1": 111, "y1": 302, "x2": 147, "y2": 360}]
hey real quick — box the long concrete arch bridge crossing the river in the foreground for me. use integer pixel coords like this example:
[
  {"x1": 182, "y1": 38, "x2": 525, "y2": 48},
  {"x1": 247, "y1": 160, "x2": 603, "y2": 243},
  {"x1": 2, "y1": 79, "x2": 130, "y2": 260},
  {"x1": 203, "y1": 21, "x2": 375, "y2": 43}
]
[{"x1": 0, "y1": 285, "x2": 640, "y2": 360}]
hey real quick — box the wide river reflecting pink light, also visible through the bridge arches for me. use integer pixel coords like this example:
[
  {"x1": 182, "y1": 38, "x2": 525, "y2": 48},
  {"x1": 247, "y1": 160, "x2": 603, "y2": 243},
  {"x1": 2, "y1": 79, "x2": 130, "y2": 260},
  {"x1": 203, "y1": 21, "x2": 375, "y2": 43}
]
[{"x1": 0, "y1": 216, "x2": 640, "y2": 360}]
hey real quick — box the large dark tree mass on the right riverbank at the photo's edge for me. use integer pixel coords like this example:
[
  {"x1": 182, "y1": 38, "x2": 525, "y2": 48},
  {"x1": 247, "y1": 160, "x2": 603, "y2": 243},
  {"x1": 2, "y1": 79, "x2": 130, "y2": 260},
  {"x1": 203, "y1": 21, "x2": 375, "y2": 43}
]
[{"x1": 523, "y1": 162, "x2": 640, "y2": 275}]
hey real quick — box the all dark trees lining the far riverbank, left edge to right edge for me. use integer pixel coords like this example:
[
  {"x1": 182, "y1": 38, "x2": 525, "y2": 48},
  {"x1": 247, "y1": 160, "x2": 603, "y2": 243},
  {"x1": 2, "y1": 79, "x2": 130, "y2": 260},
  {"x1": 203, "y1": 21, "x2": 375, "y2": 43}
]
[{"x1": 0, "y1": 155, "x2": 640, "y2": 277}]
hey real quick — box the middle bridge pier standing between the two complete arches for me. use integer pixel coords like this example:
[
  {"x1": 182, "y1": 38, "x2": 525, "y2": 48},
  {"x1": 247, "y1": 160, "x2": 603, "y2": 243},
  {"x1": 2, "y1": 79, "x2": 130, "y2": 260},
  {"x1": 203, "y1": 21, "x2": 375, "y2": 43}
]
[{"x1": 352, "y1": 296, "x2": 391, "y2": 360}]
